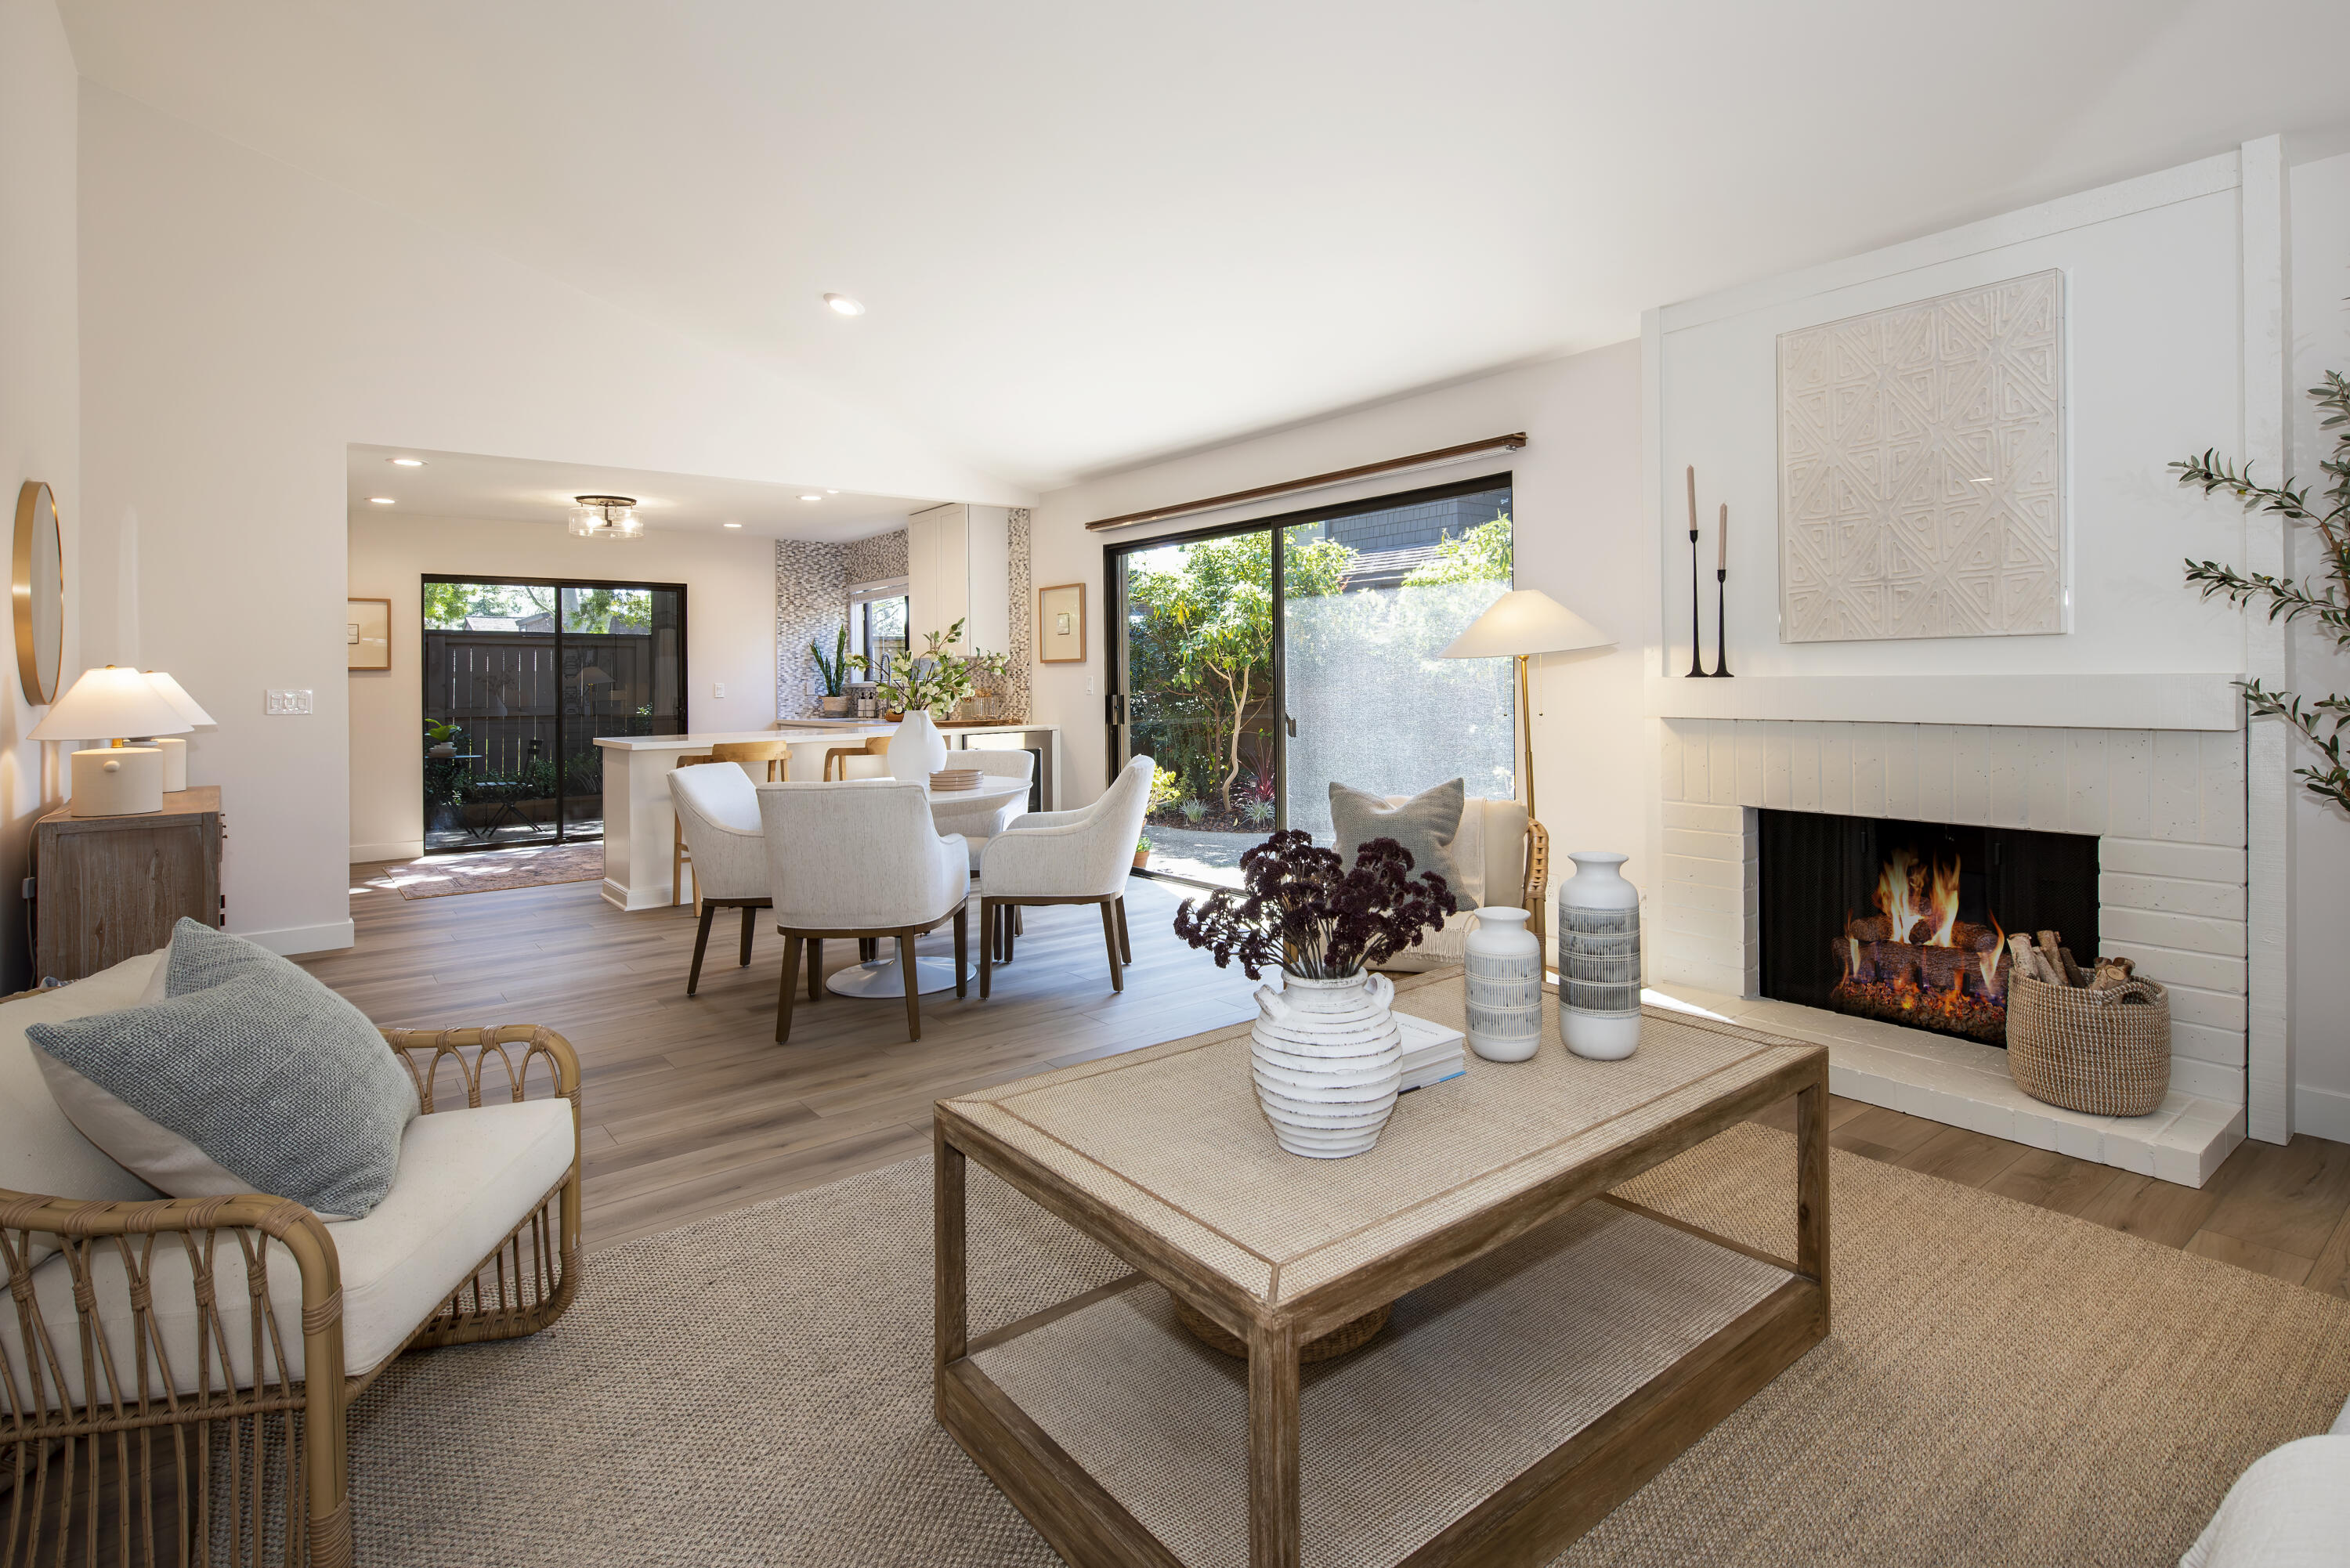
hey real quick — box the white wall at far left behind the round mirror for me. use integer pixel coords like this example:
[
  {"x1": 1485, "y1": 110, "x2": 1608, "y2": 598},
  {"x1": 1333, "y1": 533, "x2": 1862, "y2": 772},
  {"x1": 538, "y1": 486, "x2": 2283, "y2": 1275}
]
[{"x1": 0, "y1": 0, "x2": 85, "y2": 990}]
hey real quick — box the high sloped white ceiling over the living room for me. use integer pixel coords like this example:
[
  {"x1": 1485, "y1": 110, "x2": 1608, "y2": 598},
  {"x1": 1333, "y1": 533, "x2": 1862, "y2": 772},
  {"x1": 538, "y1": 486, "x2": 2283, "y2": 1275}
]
[{"x1": 63, "y1": 0, "x2": 2350, "y2": 486}]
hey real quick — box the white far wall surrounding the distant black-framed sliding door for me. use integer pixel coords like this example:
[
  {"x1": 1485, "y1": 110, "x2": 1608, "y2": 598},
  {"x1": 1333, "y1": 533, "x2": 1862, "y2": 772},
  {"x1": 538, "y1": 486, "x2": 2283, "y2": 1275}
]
[{"x1": 345, "y1": 512, "x2": 776, "y2": 863}]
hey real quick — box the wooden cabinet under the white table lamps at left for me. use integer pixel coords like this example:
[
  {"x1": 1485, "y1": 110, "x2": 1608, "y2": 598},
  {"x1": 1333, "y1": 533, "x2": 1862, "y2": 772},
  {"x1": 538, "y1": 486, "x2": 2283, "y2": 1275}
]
[{"x1": 33, "y1": 786, "x2": 221, "y2": 981}]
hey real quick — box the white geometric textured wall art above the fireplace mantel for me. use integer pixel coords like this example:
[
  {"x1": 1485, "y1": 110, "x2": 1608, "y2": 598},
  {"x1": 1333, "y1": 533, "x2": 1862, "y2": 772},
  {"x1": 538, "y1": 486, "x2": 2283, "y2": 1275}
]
[{"x1": 1779, "y1": 273, "x2": 2066, "y2": 641}]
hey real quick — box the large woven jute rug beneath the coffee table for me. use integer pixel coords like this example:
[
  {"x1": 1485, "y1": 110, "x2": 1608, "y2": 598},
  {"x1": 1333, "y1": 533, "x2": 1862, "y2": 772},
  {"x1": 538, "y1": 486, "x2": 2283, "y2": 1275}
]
[{"x1": 350, "y1": 1126, "x2": 2350, "y2": 1568}]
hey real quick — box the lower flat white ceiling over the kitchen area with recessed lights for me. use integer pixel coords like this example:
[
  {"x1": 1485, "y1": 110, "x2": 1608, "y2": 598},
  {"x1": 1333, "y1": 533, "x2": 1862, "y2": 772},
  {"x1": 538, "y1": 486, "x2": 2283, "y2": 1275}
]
[{"x1": 348, "y1": 446, "x2": 938, "y2": 540}]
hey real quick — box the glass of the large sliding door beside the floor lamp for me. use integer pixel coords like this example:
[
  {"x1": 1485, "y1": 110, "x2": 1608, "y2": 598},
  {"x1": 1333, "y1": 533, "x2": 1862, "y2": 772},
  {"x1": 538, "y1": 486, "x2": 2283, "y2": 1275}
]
[{"x1": 1107, "y1": 475, "x2": 1516, "y2": 884}]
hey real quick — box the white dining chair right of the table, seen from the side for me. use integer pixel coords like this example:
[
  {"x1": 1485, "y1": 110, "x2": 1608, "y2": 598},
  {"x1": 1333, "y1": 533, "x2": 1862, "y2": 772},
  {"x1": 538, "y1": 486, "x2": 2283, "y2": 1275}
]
[{"x1": 980, "y1": 757, "x2": 1156, "y2": 997}]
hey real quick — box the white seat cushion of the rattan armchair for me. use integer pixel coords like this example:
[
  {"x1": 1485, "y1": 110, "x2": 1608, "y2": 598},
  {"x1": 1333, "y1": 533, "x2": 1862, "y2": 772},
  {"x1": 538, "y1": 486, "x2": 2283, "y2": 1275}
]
[{"x1": 0, "y1": 1100, "x2": 578, "y2": 1404}]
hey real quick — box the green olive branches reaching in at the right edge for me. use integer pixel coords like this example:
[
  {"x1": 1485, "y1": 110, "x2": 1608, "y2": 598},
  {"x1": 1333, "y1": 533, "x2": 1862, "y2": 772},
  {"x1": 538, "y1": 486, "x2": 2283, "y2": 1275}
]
[{"x1": 2171, "y1": 371, "x2": 2350, "y2": 809}]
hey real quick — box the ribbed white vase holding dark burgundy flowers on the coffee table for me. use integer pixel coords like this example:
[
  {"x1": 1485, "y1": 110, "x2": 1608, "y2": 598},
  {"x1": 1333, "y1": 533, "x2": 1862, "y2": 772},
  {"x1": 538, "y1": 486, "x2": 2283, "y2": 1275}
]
[{"x1": 1248, "y1": 974, "x2": 1403, "y2": 1159}]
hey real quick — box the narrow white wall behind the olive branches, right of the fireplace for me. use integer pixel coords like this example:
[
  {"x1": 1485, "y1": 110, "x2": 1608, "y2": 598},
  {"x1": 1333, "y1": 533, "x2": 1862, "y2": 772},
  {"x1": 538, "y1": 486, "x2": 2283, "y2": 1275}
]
[{"x1": 2287, "y1": 155, "x2": 2350, "y2": 1143}]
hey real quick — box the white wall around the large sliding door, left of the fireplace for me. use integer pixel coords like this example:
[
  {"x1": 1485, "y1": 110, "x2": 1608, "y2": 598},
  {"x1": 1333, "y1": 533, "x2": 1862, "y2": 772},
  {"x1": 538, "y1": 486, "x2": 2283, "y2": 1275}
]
[{"x1": 1029, "y1": 343, "x2": 1654, "y2": 877}]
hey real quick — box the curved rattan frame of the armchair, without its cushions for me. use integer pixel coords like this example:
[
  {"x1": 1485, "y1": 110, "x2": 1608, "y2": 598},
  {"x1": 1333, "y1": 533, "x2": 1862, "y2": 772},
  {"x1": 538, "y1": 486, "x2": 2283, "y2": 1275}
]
[{"x1": 0, "y1": 1028, "x2": 580, "y2": 1568}]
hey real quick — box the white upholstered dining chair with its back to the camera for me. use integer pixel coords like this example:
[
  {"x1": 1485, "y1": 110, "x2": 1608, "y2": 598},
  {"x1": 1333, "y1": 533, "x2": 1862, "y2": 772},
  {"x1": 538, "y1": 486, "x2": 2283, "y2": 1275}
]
[{"x1": 757, "y1": 780, "x2": 971, "y2": 1042}]
